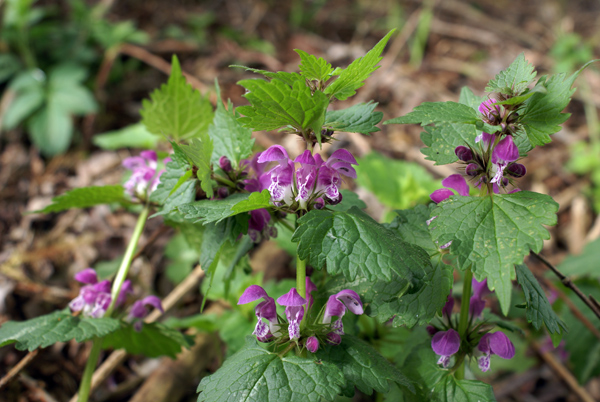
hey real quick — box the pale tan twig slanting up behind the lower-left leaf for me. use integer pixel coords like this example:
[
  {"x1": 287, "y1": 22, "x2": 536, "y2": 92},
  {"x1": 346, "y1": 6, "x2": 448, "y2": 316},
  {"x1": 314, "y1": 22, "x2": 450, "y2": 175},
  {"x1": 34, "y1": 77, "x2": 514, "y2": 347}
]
[{"x1": 69, "y1": 265, "x2": 204, "y2": 402}]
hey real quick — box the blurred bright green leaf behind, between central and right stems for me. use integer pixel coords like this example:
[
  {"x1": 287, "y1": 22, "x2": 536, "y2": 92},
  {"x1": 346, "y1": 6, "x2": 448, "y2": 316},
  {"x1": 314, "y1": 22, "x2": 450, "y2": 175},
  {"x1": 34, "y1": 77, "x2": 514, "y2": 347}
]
[{"x1": 356, "y1": 150, "x2": 440, "y2": 210}]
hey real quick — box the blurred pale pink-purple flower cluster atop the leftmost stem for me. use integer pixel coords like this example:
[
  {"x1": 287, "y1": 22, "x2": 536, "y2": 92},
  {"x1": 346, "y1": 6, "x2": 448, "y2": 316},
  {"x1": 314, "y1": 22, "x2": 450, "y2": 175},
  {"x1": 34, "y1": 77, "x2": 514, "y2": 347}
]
[{"x1": 123, "y1": 151, "x2": 171, "y2": 200}]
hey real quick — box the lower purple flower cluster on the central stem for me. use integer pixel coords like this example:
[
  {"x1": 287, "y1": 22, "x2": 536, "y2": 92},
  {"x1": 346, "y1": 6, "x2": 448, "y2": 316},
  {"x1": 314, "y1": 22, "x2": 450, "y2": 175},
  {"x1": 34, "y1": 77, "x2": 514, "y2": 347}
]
[{"x1": 238, "y1": 278, "x2": 363, "y2": 353}]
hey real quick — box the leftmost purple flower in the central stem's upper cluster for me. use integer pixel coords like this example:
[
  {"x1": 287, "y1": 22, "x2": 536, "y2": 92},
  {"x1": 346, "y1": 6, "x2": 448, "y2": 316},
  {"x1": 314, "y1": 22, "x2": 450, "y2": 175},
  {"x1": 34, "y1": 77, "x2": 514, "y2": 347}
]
[{"x1": 258, "y1": 145, "x2": 294, "y2": 205}]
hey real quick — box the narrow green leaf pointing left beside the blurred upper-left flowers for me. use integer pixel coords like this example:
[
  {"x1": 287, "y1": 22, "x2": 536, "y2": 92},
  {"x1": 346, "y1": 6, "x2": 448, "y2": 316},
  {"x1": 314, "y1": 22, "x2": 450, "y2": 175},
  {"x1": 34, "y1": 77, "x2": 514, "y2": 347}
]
[{"x1": 35, "y1": 186, "x2": 128, "y2": 214}]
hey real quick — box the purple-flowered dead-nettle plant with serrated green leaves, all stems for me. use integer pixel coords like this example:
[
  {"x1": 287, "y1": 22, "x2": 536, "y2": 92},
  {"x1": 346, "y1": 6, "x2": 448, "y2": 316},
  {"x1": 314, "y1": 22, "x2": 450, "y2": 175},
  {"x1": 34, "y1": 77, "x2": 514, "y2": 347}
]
[{"x1": 0, "y1": 31, "x2": 596, "y2": 402}]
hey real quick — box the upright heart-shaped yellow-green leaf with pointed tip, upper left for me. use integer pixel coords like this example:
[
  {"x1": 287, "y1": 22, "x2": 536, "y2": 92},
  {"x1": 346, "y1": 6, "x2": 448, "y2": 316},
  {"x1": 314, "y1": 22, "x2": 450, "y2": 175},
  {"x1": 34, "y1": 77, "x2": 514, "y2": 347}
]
[{"x1": 140, "y1": 56, "x2": 213, "y2": 141}]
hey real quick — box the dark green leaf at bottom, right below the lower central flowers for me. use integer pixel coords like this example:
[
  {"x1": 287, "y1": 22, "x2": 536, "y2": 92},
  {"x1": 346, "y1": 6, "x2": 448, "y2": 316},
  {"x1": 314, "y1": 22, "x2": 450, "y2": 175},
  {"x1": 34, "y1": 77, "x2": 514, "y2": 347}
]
[{"x1": 316, "y1": 335, "x2": 414, "y2": 396}]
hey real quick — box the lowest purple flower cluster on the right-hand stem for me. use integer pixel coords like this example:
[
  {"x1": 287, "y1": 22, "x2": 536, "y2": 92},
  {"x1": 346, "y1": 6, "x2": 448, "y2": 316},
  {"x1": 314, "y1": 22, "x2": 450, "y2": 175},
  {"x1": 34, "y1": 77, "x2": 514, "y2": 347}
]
[{"x1": 427, "y1": 279, "x2": 515, "y2": 372}]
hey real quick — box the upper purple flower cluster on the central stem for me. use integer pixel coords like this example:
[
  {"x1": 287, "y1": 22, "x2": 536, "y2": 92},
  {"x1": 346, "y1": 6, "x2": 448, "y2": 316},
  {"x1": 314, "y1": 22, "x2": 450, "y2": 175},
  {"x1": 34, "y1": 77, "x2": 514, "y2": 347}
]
[{"x1": 257, "y1": 145, "x2": 358, "y2": 209}]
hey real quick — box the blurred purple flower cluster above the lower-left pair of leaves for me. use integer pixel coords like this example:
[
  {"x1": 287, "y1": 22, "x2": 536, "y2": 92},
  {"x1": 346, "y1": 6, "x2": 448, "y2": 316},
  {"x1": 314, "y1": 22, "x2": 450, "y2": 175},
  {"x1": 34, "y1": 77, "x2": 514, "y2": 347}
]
[{"x1": 69, "y1": 268, "x2": 163, "y2": 331}]
